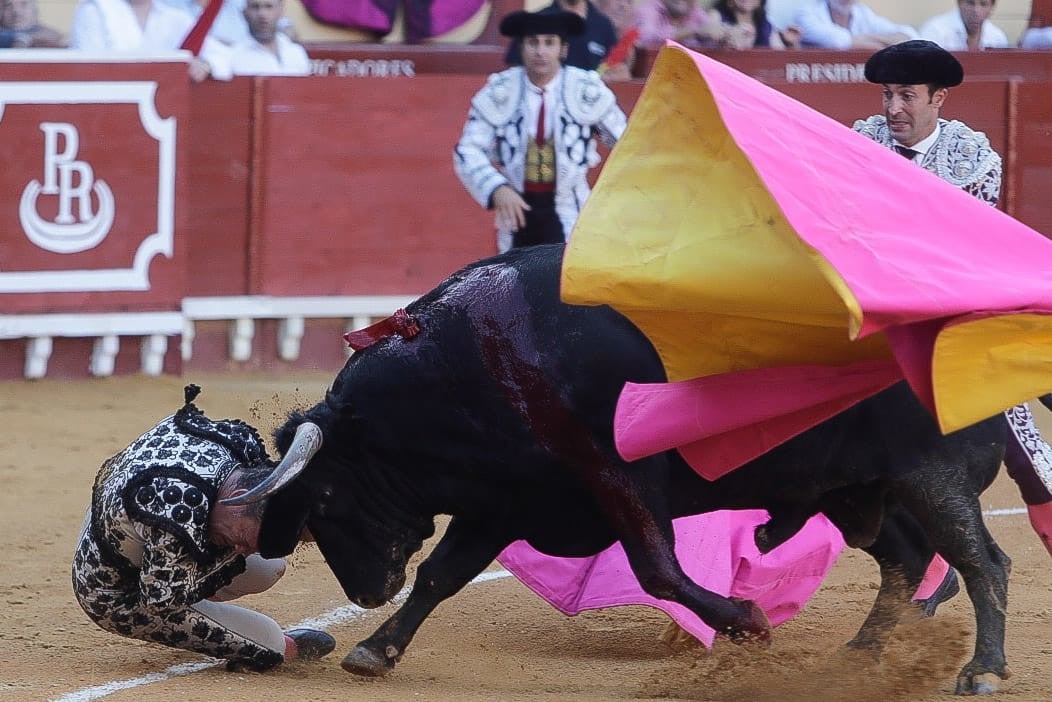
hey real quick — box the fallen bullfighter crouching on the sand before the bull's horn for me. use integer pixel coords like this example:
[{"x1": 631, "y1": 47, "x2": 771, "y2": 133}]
[{"x1": 73, "y1": 385, "x2": 336, "y2": 670}]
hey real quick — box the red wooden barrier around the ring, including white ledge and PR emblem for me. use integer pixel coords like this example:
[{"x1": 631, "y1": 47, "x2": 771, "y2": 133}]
[{"x1": 0, "y1": 0, "x2": 1052, "y2": 378}]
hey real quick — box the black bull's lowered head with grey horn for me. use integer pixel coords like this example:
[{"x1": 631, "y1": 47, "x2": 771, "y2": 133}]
[{"x1": 223, "y1": 420, "x2": 422, "y2": 608}]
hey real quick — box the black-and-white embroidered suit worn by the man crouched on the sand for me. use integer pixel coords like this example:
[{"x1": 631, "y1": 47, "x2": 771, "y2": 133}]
[{"x1": 73, "y1": 386, "x2": 283, "y2": 668}]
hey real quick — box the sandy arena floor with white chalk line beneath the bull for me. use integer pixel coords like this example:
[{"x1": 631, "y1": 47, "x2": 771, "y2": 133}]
[{"x1": 0, "y1": 374, "x2": 1052, "y2": 702}]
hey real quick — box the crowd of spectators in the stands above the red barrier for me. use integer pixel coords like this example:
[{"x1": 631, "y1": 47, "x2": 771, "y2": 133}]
[{"x1": 0, "y1": 0, "x2": 1049, "y2": 51}]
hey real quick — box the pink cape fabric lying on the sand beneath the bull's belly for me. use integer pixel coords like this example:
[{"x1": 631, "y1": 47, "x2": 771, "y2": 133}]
[{"x1": 498, "y1": 509, "x2": 844, "y2": 645}]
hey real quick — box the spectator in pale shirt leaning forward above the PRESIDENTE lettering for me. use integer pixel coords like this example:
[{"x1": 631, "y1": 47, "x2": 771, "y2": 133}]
[{"x1": 794, "y1": 0, "x2": 918, "y2": 48}]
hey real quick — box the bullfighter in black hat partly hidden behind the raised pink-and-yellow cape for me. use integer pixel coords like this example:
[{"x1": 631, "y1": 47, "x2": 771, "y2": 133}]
[{"x1": 854, "y1": 40, "x2": 1052, "y2": 555}]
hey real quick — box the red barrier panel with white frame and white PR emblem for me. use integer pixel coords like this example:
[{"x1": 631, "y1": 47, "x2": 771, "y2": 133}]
[{"x1": 0, "y1": 61, "x2": 189, "y2": 314}]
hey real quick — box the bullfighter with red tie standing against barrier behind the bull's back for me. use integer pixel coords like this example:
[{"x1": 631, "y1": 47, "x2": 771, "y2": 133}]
[{"x1": 453, "y1": 11, "x2": 627, "y2": 252}]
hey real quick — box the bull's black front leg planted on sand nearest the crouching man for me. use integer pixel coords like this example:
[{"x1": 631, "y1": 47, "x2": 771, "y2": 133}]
[{"x1": 341, "y1": 518, "x2": 508, "y2": 677}]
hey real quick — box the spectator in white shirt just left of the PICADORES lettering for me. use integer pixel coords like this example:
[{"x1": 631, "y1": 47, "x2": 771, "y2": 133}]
[{"x1": 230, "y1": 0, "x2": 310, "y2": 76}]
